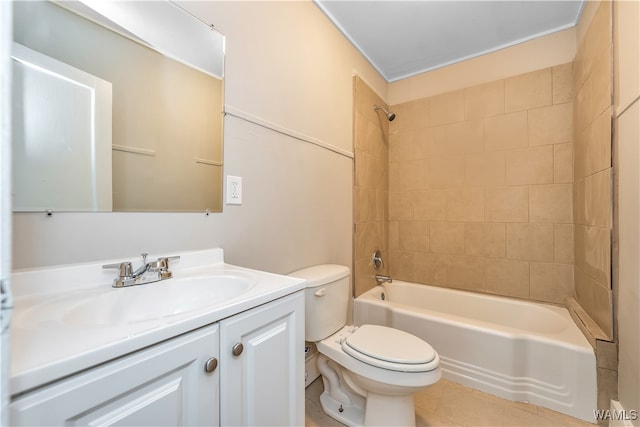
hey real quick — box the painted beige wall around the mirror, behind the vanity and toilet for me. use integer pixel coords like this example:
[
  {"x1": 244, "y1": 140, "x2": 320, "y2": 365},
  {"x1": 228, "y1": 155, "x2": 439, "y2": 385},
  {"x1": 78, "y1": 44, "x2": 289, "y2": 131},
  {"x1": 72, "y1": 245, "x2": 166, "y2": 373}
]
[{"x1": 13, "y1": 1, "x2": 386, "y2": 273}]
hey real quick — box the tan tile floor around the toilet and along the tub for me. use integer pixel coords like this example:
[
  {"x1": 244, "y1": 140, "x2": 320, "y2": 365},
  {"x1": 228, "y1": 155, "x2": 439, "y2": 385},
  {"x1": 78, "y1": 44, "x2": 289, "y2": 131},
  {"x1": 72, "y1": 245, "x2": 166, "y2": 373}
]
[{"x1": 306, "y1": 378, "x2": 594, "y2": 427}]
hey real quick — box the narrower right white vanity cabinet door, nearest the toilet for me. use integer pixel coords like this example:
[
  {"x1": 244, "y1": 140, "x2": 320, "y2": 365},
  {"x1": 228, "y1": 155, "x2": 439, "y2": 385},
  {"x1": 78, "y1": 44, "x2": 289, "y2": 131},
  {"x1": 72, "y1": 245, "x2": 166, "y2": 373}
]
[{"x1": 220, "y1": 292, "x2": 304, "y2": 426}]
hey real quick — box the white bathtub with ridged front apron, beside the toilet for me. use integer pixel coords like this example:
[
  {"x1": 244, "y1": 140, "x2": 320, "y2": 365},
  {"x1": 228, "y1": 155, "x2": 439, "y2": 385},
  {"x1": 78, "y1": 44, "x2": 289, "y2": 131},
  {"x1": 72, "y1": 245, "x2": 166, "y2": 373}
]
[{"x1": 354, "y1": 281, "x2": 597, "y2": 422}]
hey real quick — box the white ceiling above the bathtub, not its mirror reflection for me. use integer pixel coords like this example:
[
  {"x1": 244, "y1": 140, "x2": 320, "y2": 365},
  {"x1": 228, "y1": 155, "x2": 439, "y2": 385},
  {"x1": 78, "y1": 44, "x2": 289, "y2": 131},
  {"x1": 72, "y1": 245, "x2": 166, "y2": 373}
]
[{"x1": 314, "y1": 0, "x2": 584, "y2": 82}]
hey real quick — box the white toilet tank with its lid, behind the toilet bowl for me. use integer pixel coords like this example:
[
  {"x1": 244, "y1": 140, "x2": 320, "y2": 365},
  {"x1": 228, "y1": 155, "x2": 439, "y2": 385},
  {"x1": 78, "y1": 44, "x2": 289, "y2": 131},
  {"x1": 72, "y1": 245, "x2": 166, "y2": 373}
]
[{"x1": 289, "y1": 264, "x2": 350, "y2": 342}]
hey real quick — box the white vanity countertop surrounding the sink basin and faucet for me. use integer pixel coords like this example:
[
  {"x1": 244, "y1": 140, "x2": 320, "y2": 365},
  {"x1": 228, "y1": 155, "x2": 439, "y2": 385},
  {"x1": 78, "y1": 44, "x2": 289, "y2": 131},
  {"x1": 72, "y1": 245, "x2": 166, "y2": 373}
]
[{"x1": 10, "y1": 249, "x2": 305, "y2": 395}]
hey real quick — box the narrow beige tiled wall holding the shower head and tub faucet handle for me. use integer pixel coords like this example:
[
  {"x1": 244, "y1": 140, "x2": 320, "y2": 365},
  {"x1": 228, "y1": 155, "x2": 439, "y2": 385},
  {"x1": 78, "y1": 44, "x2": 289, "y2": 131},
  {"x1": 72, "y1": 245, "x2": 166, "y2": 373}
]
[{"x1": 353, "y1": 77, "x2": 389, "y2": 295}]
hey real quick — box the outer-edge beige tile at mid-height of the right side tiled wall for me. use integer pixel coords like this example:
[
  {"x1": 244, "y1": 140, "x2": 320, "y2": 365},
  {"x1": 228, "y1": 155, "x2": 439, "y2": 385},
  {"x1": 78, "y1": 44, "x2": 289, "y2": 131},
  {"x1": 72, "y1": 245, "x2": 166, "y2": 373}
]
[{"x1": 584, "y1": 169, "x2": 612, "y2": 228}]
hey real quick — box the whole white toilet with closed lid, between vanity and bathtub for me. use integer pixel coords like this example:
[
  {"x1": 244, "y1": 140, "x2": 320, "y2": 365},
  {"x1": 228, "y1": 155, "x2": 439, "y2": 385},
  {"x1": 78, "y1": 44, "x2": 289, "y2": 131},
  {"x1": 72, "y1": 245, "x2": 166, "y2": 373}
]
[{"x1": 290, "y1": 264, "x2": 440, "y2": 426}]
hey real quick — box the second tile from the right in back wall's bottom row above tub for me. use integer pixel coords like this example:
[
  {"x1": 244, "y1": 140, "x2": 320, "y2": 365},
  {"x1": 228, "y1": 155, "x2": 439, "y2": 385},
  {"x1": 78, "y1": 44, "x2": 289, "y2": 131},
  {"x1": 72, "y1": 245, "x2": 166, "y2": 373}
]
[{"x1": 484, "y1": 258, "x2": 529, "y2": 298}]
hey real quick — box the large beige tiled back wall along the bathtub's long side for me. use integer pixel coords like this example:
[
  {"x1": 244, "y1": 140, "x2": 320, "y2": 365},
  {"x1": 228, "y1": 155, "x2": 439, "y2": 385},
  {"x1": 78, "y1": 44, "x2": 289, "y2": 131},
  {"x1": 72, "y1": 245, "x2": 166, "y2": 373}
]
[{"x1": 389, "y1": 63, "x2": 573, "y2": 303}]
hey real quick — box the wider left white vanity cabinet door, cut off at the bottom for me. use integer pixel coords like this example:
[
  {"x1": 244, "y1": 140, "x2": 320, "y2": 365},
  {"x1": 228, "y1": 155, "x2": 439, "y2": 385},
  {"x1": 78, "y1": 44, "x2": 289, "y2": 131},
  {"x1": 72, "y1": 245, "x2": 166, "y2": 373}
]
[{"x1": 10, "y1": 324, "x2": 220, "y2": 426}]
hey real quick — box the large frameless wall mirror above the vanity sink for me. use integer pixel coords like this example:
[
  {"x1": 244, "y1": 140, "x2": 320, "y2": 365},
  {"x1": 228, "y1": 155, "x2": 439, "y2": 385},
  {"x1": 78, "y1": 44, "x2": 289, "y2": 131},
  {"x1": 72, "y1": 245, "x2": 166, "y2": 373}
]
[{"x1": 12, "y1": 0, "x2": 224, "y2": 212}]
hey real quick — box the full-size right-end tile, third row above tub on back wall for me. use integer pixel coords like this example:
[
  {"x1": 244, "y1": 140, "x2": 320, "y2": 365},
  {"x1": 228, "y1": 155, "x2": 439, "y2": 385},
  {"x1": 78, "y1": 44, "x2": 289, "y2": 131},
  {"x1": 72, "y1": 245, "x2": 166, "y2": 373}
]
[{"x1": 529, "y1": 184, "x2": 573, "y2": 224}]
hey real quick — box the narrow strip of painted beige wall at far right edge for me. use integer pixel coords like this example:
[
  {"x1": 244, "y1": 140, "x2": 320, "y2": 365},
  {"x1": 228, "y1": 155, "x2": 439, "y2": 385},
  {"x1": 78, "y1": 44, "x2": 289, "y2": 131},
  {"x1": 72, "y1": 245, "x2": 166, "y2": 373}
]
[{"x1": 613, "y1": 1, "x2": 640, "y2": 426}]
